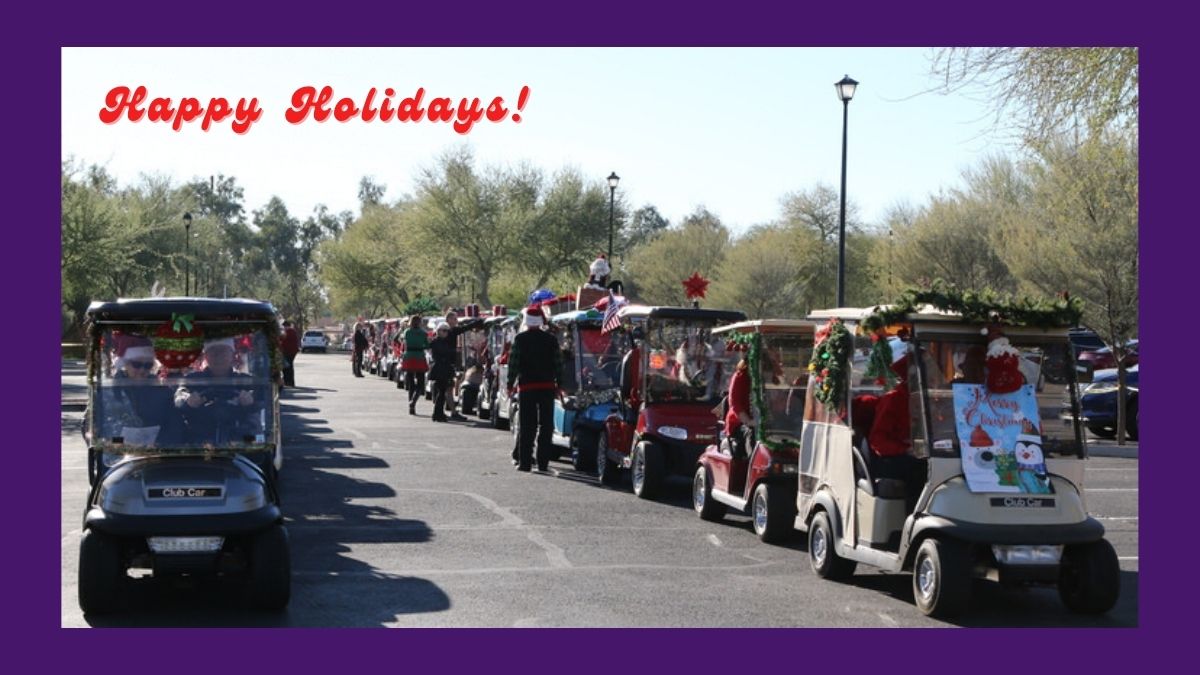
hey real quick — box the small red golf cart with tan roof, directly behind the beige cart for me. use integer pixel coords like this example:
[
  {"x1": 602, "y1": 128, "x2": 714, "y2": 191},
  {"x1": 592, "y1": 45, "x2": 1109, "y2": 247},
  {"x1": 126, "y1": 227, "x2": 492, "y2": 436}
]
[{"x1": 692, "y1": 318, "x2": 814, "y2": 543}]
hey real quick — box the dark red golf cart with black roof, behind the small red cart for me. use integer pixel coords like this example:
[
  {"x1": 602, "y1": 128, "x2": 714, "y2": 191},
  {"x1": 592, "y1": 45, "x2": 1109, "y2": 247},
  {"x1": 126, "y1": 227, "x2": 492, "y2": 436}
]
[{"x1": 596, "y1": 305, "x2": 745, "y2": 498}]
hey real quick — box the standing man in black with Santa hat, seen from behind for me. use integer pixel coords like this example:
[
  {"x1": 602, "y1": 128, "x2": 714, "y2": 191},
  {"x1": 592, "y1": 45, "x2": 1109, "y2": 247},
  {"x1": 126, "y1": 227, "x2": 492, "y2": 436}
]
[{"x1": 508, "y1": 307, "x2": 563, "y2": 472}]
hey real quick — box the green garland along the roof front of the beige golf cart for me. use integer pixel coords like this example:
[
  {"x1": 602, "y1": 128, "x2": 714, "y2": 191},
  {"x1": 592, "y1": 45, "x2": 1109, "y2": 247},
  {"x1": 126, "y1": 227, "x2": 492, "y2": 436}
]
[{"x1": 863, "y1": 279, "x2": 1084, "y2": 333}]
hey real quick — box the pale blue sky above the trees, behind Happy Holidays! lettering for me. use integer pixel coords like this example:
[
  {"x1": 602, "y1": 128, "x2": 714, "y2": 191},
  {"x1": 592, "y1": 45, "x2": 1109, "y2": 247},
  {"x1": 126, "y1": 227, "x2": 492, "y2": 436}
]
[{"x1": 62, "y1": 48, "x2": 1014, "y2": 232}]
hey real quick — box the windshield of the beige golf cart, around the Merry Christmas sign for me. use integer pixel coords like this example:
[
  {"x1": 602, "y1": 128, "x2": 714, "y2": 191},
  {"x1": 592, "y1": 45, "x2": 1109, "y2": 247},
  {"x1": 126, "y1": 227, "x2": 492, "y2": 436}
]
[{"x1": 912, "y1": 334, "x2": 1082, "y2": 458}]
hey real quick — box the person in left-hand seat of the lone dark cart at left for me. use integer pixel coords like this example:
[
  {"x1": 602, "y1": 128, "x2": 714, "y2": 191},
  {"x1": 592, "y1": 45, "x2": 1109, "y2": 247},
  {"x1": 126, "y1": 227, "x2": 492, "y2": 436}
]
[{"x1": 100, "y1": 335, "x2": 180, "y2": 446}]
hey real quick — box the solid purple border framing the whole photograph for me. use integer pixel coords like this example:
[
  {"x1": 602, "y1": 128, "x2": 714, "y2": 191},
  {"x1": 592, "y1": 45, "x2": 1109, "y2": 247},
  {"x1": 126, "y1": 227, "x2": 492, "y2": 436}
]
[{"x1": 28, "y1": 0, "x2": 1180, "y2": 671}]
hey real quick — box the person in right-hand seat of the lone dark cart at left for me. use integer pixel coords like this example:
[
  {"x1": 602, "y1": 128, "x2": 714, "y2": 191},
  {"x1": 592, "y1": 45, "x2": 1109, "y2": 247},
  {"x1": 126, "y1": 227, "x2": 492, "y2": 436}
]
[{"x1": 175, "y1": 338, "x2": 257, "y2": 444}]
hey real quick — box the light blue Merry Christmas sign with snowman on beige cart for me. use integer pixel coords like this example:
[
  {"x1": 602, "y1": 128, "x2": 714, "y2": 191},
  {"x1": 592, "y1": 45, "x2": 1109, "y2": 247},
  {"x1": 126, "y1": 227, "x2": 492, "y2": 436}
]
[{"x1": 954, "y1": 384, "x2": 1051, "y2": 495}]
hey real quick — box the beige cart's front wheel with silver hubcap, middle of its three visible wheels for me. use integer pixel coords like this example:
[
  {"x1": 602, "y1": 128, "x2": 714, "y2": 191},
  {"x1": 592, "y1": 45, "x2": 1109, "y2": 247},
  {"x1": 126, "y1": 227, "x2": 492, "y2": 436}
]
[{"x1": 912, "y1": 539, "x2": 971, "y2": 619}]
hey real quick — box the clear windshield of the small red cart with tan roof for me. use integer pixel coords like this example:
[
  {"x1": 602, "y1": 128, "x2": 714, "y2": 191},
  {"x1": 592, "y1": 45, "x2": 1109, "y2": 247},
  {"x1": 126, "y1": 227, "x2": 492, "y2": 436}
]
[{"x1": 760, "y1": 334, "x2": 812, "y2": 442}]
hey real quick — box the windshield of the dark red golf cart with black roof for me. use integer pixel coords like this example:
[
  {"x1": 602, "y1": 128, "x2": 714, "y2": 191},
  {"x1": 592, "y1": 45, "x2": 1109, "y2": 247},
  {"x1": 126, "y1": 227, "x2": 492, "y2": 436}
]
[{"x1": 642, "y1": 319, "x2": 737, "y2": 405}]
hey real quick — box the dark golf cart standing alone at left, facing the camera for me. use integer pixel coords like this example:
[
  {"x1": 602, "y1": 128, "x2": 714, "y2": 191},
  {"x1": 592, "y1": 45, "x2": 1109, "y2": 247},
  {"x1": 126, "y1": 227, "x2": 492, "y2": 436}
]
[{"x1": 79, "y1": 298, "x2": 290, "y2": 613}]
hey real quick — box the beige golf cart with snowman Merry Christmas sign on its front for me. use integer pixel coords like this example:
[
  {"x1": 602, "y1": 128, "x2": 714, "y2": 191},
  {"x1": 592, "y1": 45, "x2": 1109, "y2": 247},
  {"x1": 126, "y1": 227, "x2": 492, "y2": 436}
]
[{"x1": 796, "y1": 296, "x2": 1120, "y2": 617}]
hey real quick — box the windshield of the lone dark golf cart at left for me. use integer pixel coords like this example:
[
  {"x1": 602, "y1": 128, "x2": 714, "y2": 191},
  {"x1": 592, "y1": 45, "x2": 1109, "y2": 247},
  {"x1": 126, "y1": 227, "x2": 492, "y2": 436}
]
[{"x1": 91, "y1": 322, "x2": 276, "y2": 454}]
